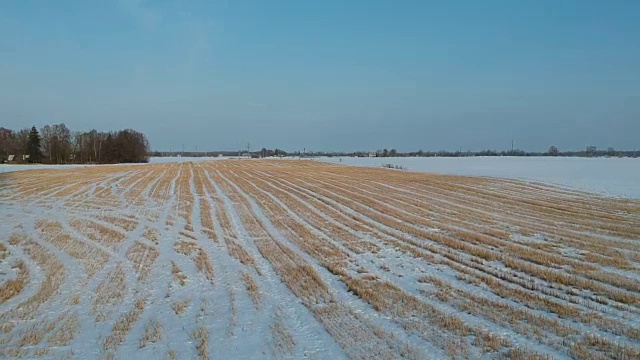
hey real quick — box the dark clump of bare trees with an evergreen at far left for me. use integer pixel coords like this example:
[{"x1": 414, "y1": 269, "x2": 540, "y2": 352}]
[{"x1": 0, "y1": 124, "x2": 149, "y2": 164}]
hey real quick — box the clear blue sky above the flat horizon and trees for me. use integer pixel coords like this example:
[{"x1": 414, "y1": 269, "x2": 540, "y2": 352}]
[{"x1": 0, "y1": 0, "x2": 640, "y2": 151}]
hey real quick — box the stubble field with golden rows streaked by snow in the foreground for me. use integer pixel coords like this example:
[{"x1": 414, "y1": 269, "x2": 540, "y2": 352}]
[{"x1": 0, "y1": 160, "x2": 640, "y2": 359}]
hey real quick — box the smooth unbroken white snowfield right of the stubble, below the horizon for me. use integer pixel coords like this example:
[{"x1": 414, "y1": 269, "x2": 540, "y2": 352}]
[{"x1": 318, "y1": 157, "x2": 640, "y2": 199}]
